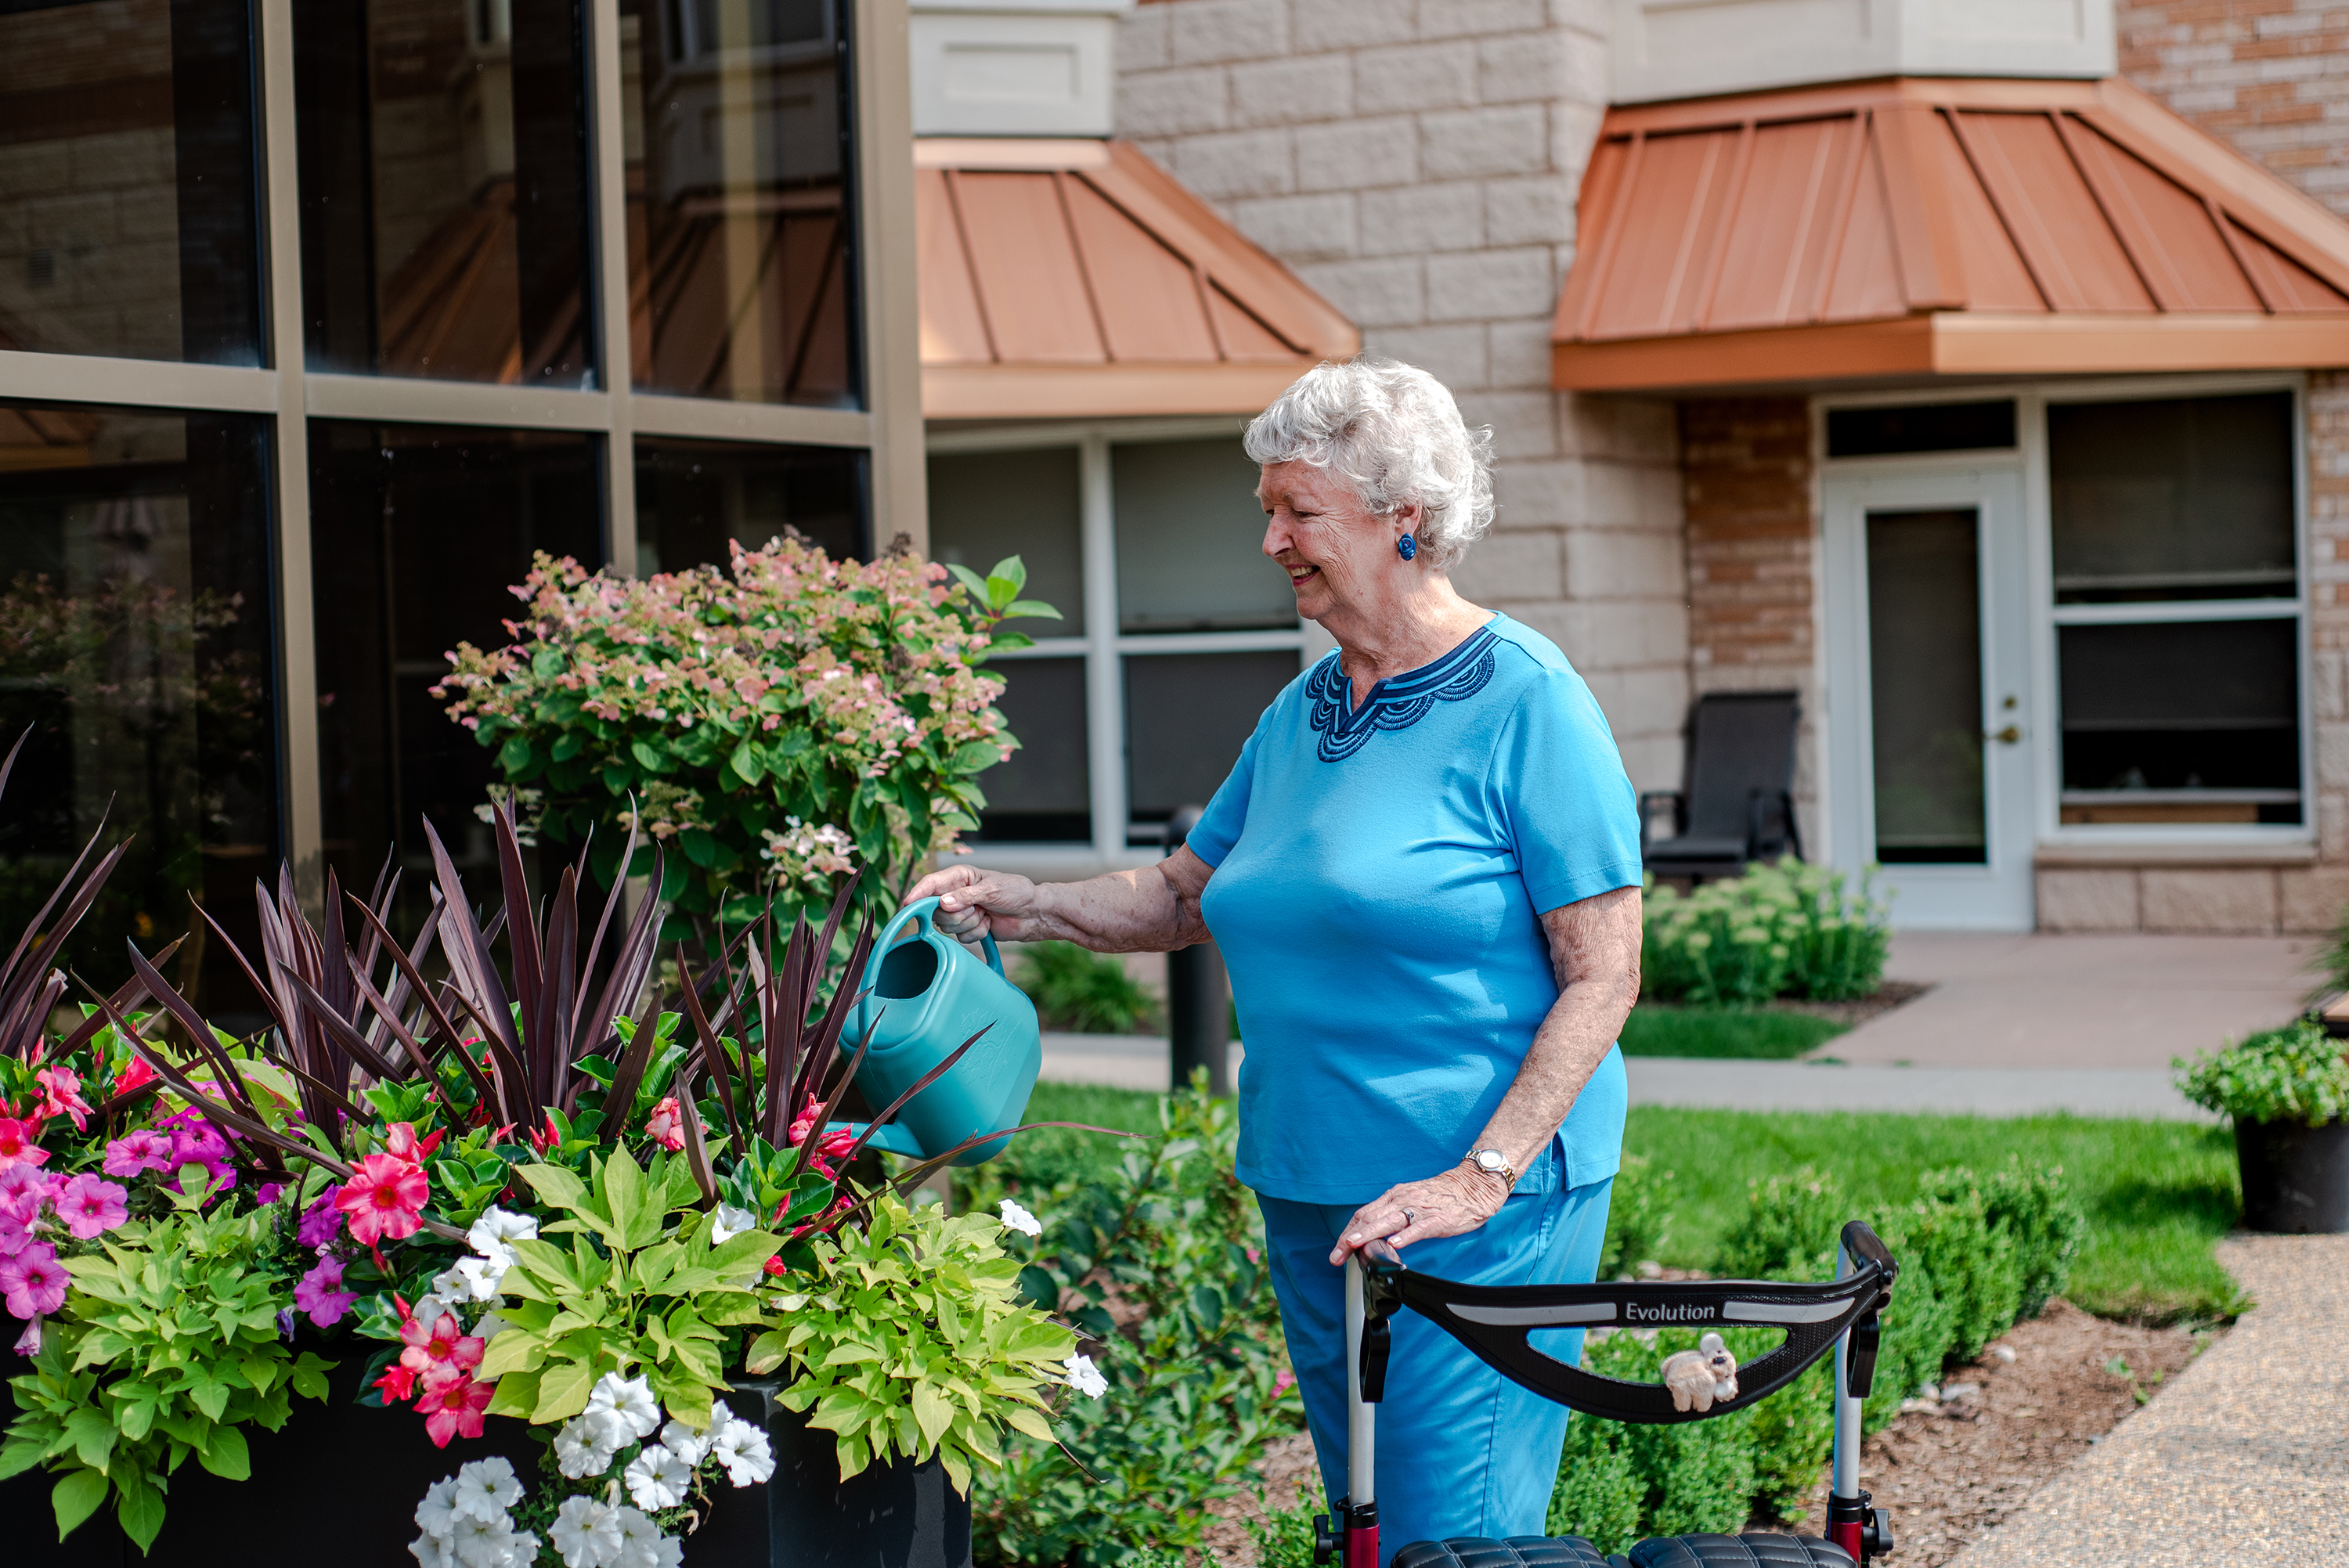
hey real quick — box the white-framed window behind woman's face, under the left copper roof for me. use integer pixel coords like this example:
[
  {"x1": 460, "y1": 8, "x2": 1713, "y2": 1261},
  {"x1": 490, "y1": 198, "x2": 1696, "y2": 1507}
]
[{"x1": 930, "y1": 432, "x2": 1304, "y2": 852}]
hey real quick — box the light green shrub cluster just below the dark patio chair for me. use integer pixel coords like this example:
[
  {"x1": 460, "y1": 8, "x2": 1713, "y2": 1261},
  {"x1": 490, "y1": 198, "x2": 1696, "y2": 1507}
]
[{"x1": 1640, "y1": 854, "x2": 1891, "y2": 1004}]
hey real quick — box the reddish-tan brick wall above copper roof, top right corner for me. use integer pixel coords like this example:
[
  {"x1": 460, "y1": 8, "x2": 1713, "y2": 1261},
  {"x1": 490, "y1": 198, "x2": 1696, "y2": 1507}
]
[{"x1": 2114, "y1": 0, "x2": 2349, "y2": 216}]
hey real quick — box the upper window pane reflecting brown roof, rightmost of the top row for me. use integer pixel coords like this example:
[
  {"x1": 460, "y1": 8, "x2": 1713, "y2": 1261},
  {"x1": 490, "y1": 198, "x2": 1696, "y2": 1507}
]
[{"x1": 620, "y1": 0, "x2": 862, "y2": 409}]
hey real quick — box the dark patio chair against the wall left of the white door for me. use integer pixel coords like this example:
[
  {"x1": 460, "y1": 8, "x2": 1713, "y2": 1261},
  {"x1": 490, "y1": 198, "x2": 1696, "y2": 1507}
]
[{"x1": 1640, "y1": 693, "x2": 1802, "y2": 878}]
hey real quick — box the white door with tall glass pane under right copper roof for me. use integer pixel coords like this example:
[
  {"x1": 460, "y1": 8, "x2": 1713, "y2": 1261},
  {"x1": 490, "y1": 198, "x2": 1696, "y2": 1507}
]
[{"x1": 1828, "y1": 470, "x2": 2032, "y2": 929}]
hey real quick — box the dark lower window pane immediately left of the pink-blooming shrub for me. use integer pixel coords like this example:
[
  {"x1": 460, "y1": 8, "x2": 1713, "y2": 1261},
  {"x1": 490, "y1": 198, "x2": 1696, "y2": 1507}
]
[{"x1": 310, "y1": 420, "x2": 604, "y2": 889}]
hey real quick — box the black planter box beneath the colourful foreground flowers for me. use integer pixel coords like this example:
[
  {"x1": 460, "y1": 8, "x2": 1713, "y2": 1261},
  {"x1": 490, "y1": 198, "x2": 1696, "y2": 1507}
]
[{"x1": 0, "y1": 1340, "x2": 970, "y2": 1568}]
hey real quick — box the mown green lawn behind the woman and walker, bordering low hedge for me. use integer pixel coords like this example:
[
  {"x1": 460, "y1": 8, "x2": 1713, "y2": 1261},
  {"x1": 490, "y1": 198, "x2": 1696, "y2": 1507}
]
[{"x1": 1003, "y1": 1089, "x2": 2243, "y2": 1321}]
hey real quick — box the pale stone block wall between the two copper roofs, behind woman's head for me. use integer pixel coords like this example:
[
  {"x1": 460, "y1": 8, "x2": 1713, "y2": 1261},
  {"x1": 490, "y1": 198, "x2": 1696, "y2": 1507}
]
[{"x1": 1118, "y1": 0, "x2": 1689, "y2": 788}]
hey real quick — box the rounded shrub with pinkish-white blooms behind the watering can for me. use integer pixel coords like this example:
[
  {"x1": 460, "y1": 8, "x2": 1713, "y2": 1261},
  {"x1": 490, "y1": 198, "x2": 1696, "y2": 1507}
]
[{"x1": 432, "y1": 538, "x2": 1059, "y2": 936}]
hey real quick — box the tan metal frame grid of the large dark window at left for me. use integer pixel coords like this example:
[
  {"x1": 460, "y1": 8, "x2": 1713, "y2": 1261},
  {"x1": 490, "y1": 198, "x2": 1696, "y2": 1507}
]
[{"x1": 0, "y1": 0, "x2": 928, "y2": 903}]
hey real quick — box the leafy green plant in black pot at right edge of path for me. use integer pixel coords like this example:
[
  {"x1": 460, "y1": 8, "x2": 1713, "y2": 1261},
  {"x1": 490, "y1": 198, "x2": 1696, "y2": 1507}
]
[{"x1": 2173, "y1": 1018, "x2": 2349, "y2": 1235}]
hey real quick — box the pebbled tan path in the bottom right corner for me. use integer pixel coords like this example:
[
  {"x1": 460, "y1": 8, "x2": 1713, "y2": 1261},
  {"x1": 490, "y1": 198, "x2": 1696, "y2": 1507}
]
[{"x1": 1945, "y1": 1235, "x2": 2349, "y2": 1568}]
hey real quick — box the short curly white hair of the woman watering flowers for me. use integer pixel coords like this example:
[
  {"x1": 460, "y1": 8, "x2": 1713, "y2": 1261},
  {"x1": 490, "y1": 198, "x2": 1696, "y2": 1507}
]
[{"x1": 1245, "y1": 355, "x2": 1492, "y2": 568}]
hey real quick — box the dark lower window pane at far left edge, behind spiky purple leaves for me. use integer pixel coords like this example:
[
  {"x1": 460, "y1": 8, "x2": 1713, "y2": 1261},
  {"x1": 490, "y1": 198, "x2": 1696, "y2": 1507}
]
[{"x1": 0, "y1": 404, "x2": 277, "y2": 1016}]
